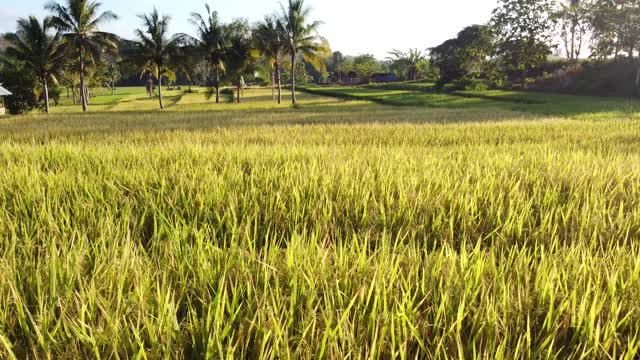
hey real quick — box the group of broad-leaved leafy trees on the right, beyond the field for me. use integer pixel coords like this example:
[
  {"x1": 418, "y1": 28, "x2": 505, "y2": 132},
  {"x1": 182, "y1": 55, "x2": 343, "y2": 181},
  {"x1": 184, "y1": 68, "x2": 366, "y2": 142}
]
[{"x1": 429, "y1": 0, "x2": 640, "y2": 88}]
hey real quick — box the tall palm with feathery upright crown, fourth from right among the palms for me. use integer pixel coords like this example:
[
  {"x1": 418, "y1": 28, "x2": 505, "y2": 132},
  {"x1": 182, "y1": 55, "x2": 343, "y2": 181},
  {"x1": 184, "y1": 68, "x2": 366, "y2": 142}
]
[{"x1": 189, "y1": 4, "x2": 229, "y2": 103}]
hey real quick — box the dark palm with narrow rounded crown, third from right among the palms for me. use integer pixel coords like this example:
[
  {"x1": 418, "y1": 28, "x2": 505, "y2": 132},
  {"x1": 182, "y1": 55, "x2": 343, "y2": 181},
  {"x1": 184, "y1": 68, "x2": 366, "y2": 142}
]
[{"x1": 224, "y1": 20, "x2": 256, "y2": 103}]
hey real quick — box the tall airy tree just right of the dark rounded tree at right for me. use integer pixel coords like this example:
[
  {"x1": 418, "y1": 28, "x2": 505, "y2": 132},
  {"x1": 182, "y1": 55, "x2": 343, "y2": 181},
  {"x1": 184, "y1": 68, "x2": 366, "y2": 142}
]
[{"x1": 491, "y1": 0, "x2": 554, "y2": 78}]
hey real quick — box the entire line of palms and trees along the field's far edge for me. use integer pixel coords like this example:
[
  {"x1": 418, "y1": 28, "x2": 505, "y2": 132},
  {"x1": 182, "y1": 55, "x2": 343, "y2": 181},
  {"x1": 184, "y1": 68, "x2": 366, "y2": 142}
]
[{"x1": 0, "y1": 0, "x2": 640, "y2": 111}]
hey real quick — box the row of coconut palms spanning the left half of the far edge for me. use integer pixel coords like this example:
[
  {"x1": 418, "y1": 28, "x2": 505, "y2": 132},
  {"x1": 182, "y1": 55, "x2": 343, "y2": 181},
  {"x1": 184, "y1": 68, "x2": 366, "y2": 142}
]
[{"x1": 1, "y1": 0, "x2": 330, "y2": 113}]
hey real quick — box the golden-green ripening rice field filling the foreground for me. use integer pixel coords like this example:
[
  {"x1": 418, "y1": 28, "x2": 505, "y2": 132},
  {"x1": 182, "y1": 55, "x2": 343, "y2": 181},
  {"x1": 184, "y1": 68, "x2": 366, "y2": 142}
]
[{"x1": 0, "y1": 86, "x2": 640, "y2": 359}]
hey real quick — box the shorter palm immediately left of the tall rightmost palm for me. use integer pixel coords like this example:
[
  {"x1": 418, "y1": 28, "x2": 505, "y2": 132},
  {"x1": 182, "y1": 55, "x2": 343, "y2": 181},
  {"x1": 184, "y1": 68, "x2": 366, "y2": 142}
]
[{"x1": 254, "y1": 16, "x2": 287, "y2": 104}]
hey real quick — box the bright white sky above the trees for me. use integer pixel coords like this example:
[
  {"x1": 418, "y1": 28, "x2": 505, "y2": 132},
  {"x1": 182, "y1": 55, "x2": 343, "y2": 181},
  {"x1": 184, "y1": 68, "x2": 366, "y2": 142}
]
[{"x1": 0, "y1": 0, "x2": 497, "y2": 59}]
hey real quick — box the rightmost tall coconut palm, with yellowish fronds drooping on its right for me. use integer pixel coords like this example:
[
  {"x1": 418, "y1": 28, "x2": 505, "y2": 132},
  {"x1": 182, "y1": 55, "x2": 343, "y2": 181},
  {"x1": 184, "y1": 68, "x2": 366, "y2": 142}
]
[{"x1": 279, "y1": 0, "x2": 328, "y2": 105}]
